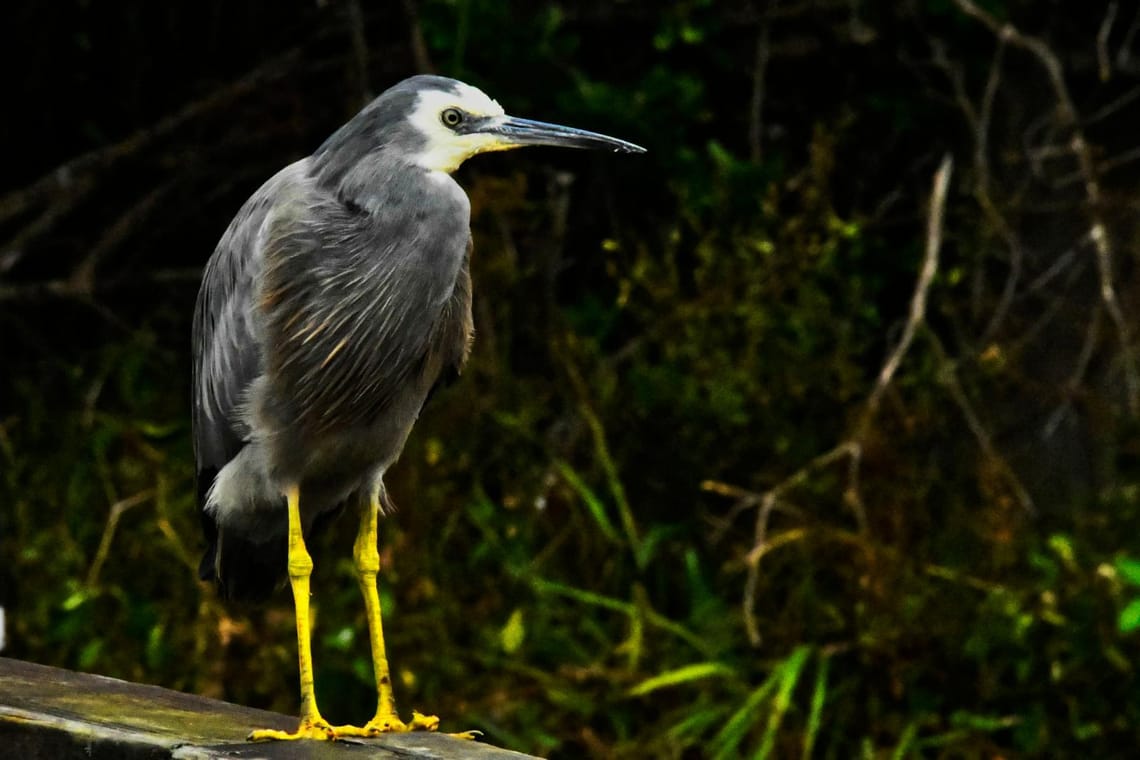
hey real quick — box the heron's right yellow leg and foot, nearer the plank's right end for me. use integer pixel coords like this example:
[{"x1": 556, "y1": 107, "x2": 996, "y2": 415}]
[{"x1": 335, "y1": 496, "x2": 474, "y2": 738}]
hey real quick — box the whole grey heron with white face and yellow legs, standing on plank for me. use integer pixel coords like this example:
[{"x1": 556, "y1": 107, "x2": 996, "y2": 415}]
[{"x1": 193, "y1": 76, "x2": 644, "y2": 739}]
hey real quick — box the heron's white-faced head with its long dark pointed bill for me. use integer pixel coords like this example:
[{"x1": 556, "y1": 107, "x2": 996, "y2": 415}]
[{"x1": 394, "y1": 76, "x2": 645, "y2": 172}]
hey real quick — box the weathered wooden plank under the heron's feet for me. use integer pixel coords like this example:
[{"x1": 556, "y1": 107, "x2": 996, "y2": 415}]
[{"x1": 0, "y1": 657, "x2": 534, "y2": 760}]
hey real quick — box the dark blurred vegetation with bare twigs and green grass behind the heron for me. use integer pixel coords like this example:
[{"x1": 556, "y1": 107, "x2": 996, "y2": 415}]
[{"x1": 0, "y1": 0, "x2": 1140, "y2": 758}]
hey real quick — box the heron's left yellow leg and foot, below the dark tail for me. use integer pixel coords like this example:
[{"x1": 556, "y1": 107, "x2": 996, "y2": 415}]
[{"x1": 250, "y1": 485, "x2": 336, "y2": 741}]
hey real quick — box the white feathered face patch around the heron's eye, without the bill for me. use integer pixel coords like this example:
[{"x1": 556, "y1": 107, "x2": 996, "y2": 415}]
[{"x1": 408, "y1": 83, "x2": 507, "y2": 173}]
